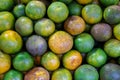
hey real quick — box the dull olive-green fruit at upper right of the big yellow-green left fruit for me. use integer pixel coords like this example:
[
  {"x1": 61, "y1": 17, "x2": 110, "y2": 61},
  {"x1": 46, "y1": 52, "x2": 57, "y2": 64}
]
[{"x1": 15, "y1": 16, "x2": 33, "y2": 36}]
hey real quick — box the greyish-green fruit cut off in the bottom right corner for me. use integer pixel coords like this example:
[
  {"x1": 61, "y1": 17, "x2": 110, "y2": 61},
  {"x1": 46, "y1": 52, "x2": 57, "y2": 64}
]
[{"x1": 100, "y1": 63, "x2": 120, "y2": 80}]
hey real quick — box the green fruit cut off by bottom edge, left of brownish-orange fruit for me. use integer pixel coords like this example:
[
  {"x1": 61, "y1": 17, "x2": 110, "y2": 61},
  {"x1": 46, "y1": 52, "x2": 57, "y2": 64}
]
[{"x1": 3, "y1": 69, "x2": 23, "y2": 80}]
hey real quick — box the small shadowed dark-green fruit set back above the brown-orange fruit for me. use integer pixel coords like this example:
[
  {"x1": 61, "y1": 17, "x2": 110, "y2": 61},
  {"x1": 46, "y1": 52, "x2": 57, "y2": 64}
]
[{"x1": 68, "y1": 1, "x2": 83, "y2": 16}]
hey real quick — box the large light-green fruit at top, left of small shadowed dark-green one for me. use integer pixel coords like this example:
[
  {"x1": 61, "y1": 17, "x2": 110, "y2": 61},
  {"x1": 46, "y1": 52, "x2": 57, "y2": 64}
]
[{"x1": 47, "y1": 2, "x2": 69, "y2": 23}]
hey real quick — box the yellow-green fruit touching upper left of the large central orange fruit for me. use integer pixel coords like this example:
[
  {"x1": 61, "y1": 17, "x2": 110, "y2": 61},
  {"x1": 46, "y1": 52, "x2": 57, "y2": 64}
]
[{"x1": 34, "y1": 18, "x2": 55, "y2": 37}]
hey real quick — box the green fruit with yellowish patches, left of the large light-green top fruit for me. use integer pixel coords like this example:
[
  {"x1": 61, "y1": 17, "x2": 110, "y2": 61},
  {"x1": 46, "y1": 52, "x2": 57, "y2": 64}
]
[{"x1": 25, "y1": 1, "x2": 46, "y2": 20}]
